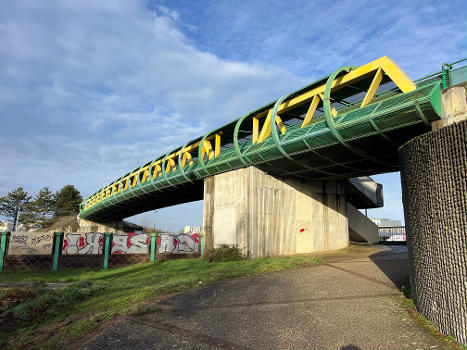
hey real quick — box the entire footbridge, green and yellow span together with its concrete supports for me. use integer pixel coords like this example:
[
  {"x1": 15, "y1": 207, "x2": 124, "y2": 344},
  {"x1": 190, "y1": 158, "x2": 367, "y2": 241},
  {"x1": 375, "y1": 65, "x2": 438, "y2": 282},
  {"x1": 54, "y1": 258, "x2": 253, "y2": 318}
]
[{"x1": 80, "y1": 57, "x2": 467, "y2": 343}]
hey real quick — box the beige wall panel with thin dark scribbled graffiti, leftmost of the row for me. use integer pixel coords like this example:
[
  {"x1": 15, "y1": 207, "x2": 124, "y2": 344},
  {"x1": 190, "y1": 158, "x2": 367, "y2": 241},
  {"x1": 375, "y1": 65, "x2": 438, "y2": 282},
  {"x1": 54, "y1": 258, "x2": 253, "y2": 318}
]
[{"x1": 8, "y1": 232, "x2": 53, "y2": 255}]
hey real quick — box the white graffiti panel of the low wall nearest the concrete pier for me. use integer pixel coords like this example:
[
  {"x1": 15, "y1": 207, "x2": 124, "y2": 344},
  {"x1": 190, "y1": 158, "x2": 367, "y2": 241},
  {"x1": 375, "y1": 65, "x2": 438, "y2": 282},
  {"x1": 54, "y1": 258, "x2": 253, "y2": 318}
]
[{"x1": 157, "y1": 233, "x2": 200, "y2": 254}]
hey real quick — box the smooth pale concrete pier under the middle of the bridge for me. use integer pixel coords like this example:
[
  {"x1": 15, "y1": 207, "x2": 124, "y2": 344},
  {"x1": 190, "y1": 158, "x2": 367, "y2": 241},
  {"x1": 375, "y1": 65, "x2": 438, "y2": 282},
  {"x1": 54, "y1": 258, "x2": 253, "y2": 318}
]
[{"x1": 204, "y1": 167, "x2": 349, "y2": 257}]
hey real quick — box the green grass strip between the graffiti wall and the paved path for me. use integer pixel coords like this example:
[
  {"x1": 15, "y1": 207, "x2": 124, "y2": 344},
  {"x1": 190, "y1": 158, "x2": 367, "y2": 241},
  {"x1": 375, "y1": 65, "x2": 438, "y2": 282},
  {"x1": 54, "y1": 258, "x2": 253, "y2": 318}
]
[{"x1": 0, "y1": 256, "x2": 320, "y2": 349}]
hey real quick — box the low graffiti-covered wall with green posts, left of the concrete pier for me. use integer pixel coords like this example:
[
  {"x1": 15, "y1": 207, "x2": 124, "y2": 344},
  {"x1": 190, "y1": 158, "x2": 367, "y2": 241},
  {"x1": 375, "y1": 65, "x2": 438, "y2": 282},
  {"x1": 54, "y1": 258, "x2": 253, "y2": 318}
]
[{"x1": 0, "y1": 232, "x2": 202, "y2": 271}]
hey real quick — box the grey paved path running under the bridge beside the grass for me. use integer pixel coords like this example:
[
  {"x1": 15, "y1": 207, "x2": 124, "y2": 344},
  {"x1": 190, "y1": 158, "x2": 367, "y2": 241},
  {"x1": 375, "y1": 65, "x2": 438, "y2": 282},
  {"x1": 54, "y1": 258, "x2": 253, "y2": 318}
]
[{"x1": 79, "y1": 248, "x2": 449, "y2": 350}]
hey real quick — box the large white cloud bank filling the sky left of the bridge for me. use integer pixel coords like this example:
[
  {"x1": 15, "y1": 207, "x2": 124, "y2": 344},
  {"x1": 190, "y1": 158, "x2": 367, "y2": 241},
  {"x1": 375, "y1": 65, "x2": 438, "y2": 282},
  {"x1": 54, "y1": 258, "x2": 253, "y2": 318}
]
[{"x1": 0, "y1": 1, "x2": 303, "y2": 205}]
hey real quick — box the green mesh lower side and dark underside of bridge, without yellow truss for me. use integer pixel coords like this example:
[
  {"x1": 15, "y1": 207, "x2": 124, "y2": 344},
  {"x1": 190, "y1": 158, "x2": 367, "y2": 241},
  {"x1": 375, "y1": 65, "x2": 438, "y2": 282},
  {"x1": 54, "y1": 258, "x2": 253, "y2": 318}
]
[{"x1": 80, "y1": 81, "x2": 440, "y2": 219}]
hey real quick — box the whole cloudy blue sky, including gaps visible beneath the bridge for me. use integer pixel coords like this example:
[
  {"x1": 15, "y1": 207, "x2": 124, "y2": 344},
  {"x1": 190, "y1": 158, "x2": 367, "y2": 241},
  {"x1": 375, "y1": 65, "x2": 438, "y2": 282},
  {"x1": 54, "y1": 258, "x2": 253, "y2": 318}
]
[{"x1": 0, "y1": 0, "x2": 467, "y2": 230}]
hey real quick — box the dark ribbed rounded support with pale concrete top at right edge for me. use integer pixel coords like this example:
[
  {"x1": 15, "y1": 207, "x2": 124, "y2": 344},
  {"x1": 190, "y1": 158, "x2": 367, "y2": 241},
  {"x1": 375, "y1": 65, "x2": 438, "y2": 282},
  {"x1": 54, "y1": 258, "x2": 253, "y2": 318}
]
[{"x1": 399, "y1": 85, "x2": 467, "y2": 344}]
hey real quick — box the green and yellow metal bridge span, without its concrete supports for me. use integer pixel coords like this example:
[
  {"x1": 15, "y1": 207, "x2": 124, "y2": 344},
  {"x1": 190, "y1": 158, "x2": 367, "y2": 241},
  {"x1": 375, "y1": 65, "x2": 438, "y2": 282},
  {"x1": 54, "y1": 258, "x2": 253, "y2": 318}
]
[{"x1": 80, "y1": 57, "x2": 465, "y2": 220}]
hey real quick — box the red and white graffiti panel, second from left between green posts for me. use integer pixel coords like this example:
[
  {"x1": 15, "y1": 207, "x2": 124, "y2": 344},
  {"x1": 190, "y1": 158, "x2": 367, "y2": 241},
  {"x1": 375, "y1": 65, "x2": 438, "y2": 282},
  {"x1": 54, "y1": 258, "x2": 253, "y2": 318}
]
[{"x1": 62, "y1": 232, "x2": 104, "y2": 255}]
